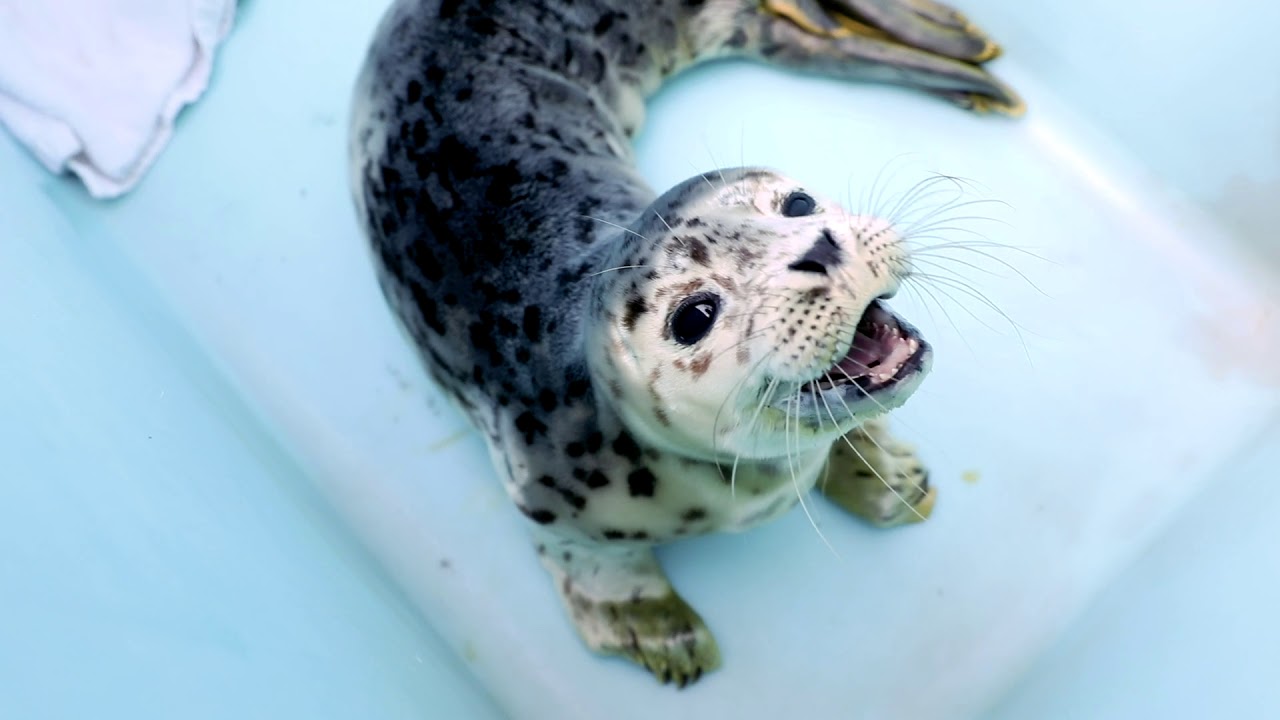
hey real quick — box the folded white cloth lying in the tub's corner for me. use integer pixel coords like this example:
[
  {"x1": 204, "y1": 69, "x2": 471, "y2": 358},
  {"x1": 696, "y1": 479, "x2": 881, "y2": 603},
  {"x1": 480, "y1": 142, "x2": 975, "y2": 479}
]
[{"x1": 0, "y1": 0, "x2": 236, "y2": 197}]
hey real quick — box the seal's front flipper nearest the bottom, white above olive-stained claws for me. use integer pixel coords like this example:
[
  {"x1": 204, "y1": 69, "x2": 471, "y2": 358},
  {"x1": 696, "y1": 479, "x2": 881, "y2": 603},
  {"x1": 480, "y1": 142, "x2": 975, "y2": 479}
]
[{"x1": 536, "y1": 530, "x2": 721, "y2": 687}]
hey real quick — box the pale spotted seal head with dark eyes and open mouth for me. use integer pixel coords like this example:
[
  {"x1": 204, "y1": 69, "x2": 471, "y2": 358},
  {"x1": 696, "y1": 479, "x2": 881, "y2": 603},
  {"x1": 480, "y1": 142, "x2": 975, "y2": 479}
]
[{"x1": 584, "y1": 168, "x2": 931, "y2": 461}]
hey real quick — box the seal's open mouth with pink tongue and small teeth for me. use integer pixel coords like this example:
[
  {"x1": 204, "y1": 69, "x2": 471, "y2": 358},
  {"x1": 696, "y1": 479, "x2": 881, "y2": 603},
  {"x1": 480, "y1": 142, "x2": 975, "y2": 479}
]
[{"x1": 794, "y1": 300, "x2": 932, "y2": 415}]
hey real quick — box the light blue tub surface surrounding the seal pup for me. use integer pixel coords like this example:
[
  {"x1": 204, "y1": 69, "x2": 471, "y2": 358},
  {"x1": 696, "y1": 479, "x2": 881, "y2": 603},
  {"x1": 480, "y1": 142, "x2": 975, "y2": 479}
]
[{"x1": 0, "y1": 0, "x2": 1280, "y2": 719}]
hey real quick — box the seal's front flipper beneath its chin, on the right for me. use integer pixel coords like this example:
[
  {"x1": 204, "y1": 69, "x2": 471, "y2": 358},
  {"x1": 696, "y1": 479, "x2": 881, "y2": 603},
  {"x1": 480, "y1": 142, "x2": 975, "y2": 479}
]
[{"x1": 818, "y1": 420, "x2": 938, "y2": 528}]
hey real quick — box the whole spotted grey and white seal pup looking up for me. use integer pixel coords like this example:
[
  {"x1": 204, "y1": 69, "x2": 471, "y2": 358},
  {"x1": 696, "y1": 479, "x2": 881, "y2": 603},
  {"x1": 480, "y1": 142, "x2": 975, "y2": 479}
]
[{"x1": 351, "y1": 0, "x2": 1021, "y2": 685}]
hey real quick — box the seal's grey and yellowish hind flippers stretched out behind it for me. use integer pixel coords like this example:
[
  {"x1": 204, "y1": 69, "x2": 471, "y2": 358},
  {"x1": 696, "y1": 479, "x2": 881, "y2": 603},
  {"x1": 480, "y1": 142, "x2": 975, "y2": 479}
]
[{"x1": 726, "y1": 0, "x2": 1025, "y2": 117}]
